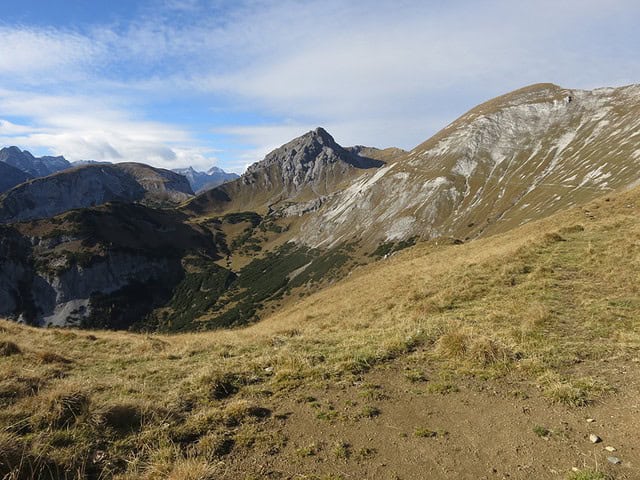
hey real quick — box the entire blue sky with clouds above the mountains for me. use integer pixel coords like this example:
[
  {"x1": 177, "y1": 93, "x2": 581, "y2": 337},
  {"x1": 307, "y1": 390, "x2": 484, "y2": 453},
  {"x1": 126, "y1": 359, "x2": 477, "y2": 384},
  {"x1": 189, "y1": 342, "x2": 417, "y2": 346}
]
[{"x1": 0, "y1": 0, "x2": 640, "y2": 173}]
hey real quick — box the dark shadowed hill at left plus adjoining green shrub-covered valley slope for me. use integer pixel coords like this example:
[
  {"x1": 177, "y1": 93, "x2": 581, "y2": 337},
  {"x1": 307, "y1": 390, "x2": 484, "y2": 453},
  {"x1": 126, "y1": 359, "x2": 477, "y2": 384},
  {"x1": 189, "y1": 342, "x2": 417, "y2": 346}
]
[{"x1": 0, "y1": 203, "x2": 362, "y2": 332}]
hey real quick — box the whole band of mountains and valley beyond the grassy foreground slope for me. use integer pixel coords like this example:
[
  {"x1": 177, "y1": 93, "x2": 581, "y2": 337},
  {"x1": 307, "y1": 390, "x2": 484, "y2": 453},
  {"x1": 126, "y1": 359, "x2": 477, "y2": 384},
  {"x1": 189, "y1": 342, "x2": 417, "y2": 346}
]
[{"x1": 0, "y1": 84, "x2": 640, "y2": 331}]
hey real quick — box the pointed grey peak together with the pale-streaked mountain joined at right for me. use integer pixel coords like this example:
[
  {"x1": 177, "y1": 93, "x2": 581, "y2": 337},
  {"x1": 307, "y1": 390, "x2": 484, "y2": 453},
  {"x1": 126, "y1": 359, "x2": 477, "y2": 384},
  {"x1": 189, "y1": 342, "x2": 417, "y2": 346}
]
[{"x1": 179, "y1": 84, "x2": 640, "y2": 249}]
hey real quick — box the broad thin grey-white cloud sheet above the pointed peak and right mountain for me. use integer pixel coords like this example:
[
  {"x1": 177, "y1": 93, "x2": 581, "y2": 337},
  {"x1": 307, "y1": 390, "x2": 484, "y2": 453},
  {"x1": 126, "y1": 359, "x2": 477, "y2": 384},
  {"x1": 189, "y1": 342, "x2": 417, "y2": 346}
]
[{"x1": 176, "y1": 0, "x2": 640, "y2": 156}]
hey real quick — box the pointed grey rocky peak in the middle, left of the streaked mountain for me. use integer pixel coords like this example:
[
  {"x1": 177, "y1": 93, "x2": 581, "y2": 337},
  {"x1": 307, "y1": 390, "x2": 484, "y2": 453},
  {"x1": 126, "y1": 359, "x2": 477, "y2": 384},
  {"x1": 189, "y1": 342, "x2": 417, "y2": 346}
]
[{"x1": 185, "y1": 128, "x2": 384, "y2": 213}]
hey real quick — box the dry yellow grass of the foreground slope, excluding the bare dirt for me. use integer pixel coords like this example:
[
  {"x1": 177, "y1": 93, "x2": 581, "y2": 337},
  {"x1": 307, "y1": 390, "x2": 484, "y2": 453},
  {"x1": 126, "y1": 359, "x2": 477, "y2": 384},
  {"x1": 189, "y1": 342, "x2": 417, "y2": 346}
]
[{"x1": 0, "y1": 186, "x2": 640, "y2": 479}]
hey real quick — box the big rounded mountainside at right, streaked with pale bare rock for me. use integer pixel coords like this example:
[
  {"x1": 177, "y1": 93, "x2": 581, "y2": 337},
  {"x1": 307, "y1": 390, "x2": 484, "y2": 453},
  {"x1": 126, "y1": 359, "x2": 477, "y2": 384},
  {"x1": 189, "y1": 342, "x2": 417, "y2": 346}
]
[{"x1": 298, "y1": 84, "x2": 640, "y2": 246}]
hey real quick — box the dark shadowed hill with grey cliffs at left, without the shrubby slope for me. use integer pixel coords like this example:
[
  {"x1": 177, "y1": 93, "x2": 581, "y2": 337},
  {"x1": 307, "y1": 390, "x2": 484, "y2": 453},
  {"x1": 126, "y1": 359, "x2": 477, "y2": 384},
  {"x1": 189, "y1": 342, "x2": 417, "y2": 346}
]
[{"x1": 0, "y1": 204, "x2": 217, "y2": 328}]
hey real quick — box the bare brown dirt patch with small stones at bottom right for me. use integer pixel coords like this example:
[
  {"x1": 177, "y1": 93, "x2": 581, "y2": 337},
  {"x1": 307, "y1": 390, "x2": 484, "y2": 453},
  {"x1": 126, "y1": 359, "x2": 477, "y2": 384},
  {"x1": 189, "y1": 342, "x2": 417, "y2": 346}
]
[{"x1": 219, "y1": 364, "x2": 640, "y2": 480}]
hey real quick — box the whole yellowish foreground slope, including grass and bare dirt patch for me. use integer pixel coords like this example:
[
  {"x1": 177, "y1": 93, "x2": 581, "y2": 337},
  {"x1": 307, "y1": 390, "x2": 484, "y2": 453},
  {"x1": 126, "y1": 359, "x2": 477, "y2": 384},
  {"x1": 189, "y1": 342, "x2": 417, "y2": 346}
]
[{"x1": 0, "y1": 186, "x2": 640, "y2": 479}]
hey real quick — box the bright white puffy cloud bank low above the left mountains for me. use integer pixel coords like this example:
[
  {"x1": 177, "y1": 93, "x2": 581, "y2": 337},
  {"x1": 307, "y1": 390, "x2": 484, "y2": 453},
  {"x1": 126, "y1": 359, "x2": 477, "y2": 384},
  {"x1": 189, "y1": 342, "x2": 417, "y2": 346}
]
[{"x1": 0, "y1": 90, "x2": 220, "y2": 169}]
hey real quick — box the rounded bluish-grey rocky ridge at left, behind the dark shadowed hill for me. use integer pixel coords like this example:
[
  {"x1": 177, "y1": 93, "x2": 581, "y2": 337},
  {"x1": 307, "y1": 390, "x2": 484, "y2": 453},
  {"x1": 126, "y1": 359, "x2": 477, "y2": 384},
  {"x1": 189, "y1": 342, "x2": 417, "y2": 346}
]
[{"x1": 0, "y1": 163, "x2": 193, "y2": 223}]
